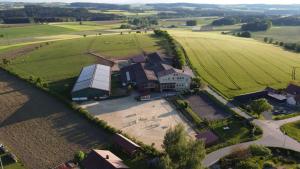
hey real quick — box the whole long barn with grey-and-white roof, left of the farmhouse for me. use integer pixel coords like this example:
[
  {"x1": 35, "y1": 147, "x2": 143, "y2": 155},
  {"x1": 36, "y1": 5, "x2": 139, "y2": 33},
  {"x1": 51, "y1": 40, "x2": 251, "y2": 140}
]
[{"x1": 71, "y1": 64, "x2": 111, "y2": 101}]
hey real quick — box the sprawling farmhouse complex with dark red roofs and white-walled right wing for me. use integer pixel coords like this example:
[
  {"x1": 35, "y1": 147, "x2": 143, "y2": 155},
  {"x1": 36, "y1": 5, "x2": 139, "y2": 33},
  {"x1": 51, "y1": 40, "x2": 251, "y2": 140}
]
[{"x1": 120, "y1": 53, "x2": 194, "y2": 92}]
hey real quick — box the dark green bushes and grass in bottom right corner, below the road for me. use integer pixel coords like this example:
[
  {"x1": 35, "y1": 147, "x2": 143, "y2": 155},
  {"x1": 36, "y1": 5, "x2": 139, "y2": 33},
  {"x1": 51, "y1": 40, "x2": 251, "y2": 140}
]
[{"x1": 214, "y1": 145, "x2": 300, "y2": 169}]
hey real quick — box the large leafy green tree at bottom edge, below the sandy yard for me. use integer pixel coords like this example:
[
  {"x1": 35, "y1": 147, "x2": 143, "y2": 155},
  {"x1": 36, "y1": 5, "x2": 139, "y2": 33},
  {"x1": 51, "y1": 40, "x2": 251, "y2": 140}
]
[{"x1": 160, "y1": 124, "x2": 205, "y2": 169}]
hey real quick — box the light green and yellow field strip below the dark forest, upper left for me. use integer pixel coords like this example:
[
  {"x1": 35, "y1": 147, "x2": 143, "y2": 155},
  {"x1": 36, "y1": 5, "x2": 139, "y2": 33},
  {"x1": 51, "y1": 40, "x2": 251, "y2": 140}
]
[{"x1": 0, "y1": 21, "x2": 120, "y2": 47}]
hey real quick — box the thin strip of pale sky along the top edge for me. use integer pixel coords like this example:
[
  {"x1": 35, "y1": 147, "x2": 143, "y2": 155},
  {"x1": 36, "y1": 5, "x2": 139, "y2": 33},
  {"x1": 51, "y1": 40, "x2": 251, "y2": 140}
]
[{"x1": 0, "y1": 0, "x2": 300, "y2": 4}]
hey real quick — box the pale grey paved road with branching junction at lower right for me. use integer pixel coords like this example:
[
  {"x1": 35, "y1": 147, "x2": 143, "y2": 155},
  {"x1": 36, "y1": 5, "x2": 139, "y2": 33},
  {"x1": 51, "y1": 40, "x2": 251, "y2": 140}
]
[{"x1": 203, "y1": 88, "x2": 300, "y2": 167}]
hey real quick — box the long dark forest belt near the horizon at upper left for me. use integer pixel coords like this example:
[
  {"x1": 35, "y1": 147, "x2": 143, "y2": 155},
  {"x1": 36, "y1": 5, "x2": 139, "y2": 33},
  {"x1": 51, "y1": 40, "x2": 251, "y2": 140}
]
[{"x1": 0, "y1": 5, "x2": 122, "y2": 24}]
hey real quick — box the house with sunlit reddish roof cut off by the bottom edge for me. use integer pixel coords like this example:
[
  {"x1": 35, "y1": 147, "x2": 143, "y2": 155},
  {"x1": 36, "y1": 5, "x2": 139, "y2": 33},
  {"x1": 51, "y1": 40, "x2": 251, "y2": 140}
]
[{"x1": 82, "y1": 150, "x2": 129, "y2": 169}]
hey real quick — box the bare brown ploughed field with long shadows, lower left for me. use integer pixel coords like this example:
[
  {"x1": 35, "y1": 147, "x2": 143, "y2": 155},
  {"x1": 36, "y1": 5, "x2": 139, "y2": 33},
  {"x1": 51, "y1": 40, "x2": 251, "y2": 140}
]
[{"x1": 0, "y1": 69, "x2": 107, "y2": 169}]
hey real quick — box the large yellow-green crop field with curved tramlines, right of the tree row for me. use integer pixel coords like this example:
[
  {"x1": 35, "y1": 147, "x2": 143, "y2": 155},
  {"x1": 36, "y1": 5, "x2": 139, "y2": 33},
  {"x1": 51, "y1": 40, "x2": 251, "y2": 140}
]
[{"x1": 170, "y1": 31, "x2": 300, "y2": 98}]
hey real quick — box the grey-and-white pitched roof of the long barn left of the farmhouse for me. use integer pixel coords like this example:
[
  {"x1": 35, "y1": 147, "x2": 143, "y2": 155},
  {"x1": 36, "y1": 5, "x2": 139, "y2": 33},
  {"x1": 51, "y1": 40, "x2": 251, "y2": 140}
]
[{"x1": 72, "y1": 64, "x2": 111, "y2": 92}]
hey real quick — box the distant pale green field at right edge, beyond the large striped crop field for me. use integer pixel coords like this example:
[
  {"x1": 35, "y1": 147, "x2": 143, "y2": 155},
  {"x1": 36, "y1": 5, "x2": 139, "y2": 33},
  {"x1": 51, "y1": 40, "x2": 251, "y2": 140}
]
[{"x1": 252, "y1": 26, "x2": 300, "y2": 42}]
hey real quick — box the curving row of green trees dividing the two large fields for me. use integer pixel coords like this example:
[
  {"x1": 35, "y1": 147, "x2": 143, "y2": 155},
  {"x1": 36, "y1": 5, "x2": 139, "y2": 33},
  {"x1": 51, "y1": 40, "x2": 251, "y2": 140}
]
[{"x1": 154, "y1": 30, "x2": 186, "y2": 69}]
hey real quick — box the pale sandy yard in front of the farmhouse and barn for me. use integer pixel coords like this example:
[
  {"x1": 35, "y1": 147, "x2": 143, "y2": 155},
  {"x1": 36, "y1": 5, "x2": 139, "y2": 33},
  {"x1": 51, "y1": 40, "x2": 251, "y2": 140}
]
[{"x1": 82, "y1": 95, "x2": 195, "y2": 149}]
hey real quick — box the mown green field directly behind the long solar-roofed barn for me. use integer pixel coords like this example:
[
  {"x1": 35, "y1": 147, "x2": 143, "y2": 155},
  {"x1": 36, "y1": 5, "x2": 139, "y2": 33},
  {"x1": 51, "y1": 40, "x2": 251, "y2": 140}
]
[{"x1": 2, "y1": 34, "x2": 160, "y2": 96}]
